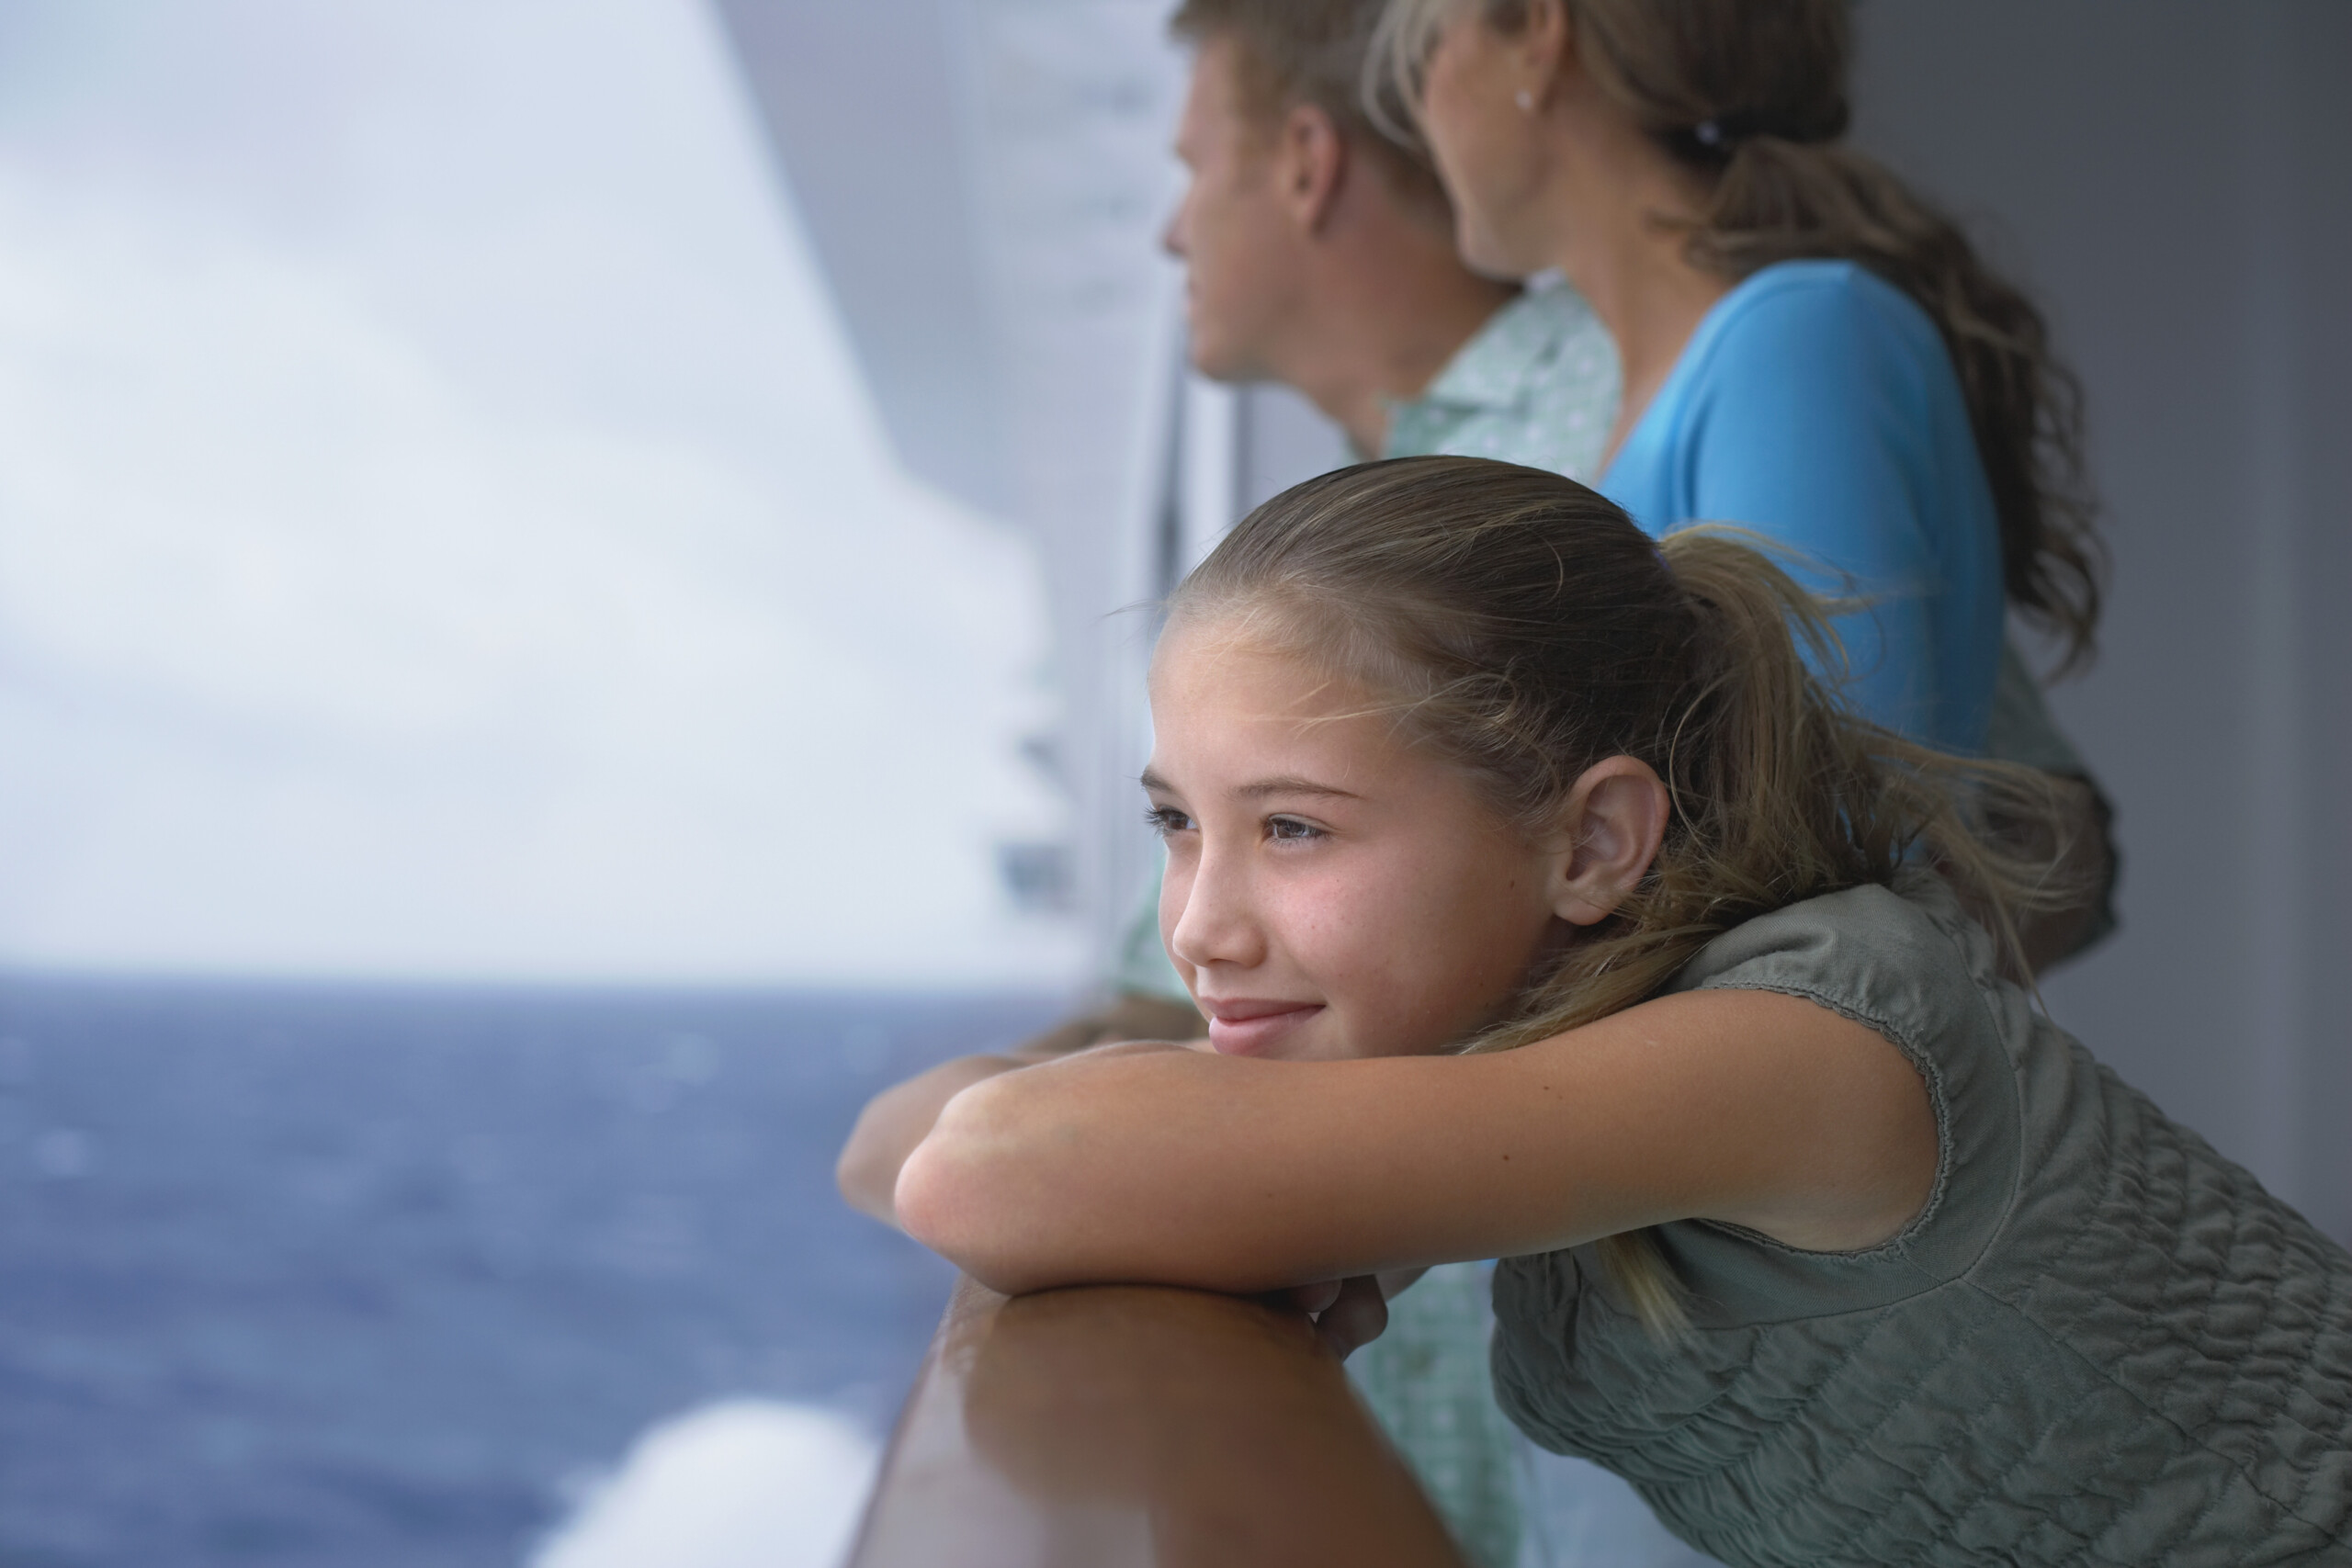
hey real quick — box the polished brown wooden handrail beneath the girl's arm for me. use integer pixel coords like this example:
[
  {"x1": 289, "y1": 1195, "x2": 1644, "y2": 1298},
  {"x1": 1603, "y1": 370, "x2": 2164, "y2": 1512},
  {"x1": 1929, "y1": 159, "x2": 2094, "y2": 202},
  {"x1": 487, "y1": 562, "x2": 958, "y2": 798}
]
[{"x1": 849, "y1": 1279, "x2": 1463, "y2": 1568}]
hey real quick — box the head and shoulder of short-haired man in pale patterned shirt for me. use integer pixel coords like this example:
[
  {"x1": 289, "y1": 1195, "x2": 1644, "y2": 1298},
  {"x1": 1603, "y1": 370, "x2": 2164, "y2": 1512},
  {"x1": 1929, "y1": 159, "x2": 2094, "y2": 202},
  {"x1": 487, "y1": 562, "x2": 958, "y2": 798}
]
[{"x1": 1167, "y1": 0, "x2": 1616, "y2": 475}]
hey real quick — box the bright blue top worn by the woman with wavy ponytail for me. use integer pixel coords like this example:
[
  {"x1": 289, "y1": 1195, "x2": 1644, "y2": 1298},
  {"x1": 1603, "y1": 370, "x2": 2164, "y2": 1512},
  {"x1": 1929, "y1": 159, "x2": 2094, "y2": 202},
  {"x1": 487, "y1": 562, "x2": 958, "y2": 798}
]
[{"x1": 1600, "y1": 261, "x2": 2004, "y2": 755}]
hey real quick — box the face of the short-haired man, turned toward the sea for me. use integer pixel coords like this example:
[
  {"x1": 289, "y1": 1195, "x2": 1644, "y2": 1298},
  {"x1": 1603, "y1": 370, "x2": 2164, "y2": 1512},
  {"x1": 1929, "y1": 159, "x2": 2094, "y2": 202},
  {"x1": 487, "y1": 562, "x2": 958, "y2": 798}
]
[{"x1": 1164, "y1": 38, "x2": 1303, "y2": 381}]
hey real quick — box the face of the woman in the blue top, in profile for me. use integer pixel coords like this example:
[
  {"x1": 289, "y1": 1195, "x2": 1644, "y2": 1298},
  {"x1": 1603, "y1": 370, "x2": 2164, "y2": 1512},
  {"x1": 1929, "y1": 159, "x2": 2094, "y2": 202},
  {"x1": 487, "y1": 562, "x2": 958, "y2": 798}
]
[{"x1": 1420, "y1": 3, "x2": 1555, "y2": 277}]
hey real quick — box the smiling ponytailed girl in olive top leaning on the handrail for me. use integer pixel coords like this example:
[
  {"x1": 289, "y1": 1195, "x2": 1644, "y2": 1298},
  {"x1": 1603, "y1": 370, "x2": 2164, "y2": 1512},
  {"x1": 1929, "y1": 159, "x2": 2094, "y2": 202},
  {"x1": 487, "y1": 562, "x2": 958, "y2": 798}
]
[{"x1": 844, "y1": 458, "x2": 2352, "y2": 1565}]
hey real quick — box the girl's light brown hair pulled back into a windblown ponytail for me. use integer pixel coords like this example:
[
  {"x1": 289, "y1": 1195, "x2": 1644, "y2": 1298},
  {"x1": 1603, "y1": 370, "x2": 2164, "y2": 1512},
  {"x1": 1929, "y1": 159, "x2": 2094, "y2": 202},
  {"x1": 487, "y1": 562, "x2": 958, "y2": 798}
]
[{"x1": 1169, "y1": 458, "x2": 2067, "y2": 1333}]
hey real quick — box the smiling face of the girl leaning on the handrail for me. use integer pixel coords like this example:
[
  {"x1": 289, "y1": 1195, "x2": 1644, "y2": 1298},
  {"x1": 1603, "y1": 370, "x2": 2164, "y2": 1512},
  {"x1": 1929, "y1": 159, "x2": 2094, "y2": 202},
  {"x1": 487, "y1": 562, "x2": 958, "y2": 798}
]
[{"x1": 1143, "y1": 623, "x2": 1569, "y2": 1060}]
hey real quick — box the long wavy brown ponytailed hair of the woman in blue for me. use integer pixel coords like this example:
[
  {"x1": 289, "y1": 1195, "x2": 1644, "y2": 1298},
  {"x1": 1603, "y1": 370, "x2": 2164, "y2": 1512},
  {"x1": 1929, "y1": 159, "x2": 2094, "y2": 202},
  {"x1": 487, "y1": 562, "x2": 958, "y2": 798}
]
[{"x1": 1364, "y1": 0, "x2": 2105, "y2": 670}]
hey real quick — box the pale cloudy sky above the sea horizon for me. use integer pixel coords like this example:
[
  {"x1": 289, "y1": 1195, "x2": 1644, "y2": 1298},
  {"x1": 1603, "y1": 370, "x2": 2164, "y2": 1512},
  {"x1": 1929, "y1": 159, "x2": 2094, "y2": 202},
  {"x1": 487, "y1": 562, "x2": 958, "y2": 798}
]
[{"x1": 0, "y1": 0, "x2": 1077, "y2": 985}]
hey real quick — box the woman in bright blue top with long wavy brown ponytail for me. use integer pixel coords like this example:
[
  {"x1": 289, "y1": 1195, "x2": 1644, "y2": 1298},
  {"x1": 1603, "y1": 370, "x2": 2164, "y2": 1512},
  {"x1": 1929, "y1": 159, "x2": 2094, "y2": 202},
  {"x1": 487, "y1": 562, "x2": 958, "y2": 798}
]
[{"x1": 1381, "y1": 0, "x2": 2098, "y2": 752}]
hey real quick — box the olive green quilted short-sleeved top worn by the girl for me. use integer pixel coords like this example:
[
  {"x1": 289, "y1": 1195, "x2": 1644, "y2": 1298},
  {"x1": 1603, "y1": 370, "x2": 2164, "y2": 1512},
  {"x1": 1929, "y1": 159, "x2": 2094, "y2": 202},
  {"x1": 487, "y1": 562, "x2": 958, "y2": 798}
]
[{"x1": 1494, "y1": 877, "x2": 2352, "y2": 1568}]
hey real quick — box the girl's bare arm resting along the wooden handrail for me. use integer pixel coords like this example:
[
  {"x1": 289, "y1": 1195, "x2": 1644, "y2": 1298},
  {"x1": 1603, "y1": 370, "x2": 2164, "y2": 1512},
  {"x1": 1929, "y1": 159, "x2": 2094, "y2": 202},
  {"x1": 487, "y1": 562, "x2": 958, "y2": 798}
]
[{"x1": 894, "y1": 989, "x2": 1936, "y2": 1291}]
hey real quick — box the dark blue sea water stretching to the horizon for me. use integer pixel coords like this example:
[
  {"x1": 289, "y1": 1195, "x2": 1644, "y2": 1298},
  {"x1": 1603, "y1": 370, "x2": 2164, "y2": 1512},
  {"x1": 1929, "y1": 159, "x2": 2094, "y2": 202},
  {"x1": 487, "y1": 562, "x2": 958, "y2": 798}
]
[{"x1": 0, "y1": 978, "x2": 1054, "y2": 1568}]
